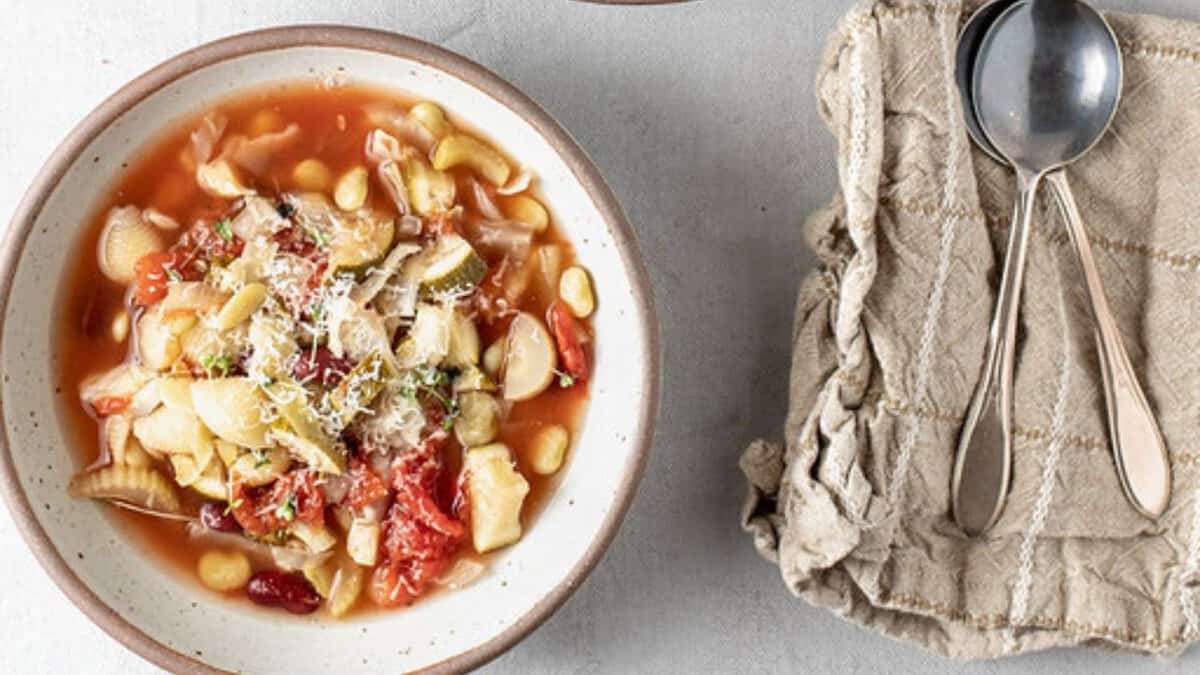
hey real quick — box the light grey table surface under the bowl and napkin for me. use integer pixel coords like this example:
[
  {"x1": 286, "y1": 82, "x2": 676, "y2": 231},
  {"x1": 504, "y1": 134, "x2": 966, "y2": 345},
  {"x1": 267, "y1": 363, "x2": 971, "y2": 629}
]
[{"x1": 0, "y1": 0, "x2": 1200, "y2": 675}]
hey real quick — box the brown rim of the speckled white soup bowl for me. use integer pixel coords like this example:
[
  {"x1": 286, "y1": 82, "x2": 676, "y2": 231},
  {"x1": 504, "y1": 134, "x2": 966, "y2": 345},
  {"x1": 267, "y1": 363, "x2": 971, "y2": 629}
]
[{"x1": 0, "y1": 25, "x2": 659, "y2": 674}]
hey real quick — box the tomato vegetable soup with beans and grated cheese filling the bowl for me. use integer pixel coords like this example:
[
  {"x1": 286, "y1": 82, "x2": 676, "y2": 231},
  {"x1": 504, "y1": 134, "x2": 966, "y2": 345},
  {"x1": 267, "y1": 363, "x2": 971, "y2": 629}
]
[{"x1": 59, "y1": 83, "x2": 595, "y2": 616}]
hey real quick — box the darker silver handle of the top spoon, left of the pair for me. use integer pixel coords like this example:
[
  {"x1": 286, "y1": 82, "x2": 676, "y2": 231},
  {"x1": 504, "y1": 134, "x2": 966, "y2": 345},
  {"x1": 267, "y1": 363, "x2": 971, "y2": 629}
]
[{"x1": 950, "y1": 172, "x2": 1042, "y2": 536}]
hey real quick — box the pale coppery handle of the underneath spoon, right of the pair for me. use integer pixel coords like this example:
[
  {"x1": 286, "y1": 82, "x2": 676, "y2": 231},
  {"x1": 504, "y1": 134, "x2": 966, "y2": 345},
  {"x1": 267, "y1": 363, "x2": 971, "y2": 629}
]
[{"x1": 1046, "y1": 171, "x2": 1171, "y2": 518}]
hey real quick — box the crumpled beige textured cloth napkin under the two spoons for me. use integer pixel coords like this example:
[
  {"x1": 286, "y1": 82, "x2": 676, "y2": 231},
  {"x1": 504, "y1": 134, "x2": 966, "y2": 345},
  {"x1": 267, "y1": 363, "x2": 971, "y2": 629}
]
[{"x1": 740, "y1": 0, "x2": 1200, "y2": 658}]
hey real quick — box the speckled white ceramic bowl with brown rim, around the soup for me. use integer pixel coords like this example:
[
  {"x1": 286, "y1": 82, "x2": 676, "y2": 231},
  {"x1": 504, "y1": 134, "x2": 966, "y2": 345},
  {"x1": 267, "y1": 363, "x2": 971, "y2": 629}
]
[{"x1": 0, "y1": 26, "x2": 659, "y2": 673}]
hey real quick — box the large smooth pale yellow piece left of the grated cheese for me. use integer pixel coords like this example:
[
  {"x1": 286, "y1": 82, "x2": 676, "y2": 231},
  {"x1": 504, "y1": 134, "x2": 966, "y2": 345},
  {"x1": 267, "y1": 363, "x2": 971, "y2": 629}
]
[{"x1": 192, "y1": 377, "x2": 270, "y2": 448}]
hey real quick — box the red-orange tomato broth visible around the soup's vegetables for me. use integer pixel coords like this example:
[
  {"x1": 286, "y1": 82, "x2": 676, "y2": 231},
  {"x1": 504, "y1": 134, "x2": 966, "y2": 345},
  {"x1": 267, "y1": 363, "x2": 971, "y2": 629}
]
[{"x1": 55, "y1": 82, "x2": 592, "y2": 614}]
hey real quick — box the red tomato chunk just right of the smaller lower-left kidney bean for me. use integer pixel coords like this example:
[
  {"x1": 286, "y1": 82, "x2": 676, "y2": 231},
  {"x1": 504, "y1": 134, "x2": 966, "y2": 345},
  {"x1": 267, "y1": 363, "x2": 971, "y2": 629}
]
[{"x1": 229, "y1": 468, "x2": 325, "y2": 536}]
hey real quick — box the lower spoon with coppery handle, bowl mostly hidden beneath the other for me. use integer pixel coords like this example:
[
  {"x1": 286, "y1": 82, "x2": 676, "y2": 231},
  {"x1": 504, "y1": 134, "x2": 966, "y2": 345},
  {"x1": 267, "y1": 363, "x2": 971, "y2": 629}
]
[{"x1": 955, "y1": 0, "x2": 1170, "y2": 526}]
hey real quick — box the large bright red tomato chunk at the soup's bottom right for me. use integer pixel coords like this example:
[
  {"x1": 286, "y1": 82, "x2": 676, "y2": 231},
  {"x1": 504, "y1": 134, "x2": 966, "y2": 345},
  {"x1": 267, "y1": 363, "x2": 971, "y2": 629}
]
[{"x1": 368, "y1": 444, "x2": 467, "y2": 607}]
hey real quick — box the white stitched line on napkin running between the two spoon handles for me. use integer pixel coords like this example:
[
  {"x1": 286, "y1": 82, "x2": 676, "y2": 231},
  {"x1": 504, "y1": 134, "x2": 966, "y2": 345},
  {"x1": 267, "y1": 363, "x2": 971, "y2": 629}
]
[{"x1": 1004, "y1": 256, "x2": 1073, "y2": 652}]
